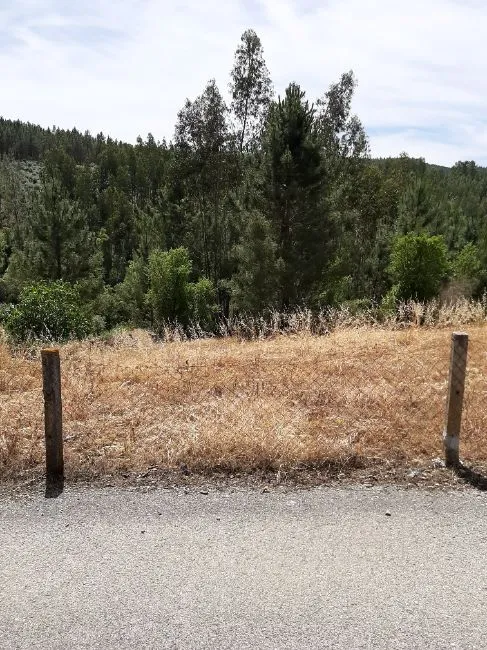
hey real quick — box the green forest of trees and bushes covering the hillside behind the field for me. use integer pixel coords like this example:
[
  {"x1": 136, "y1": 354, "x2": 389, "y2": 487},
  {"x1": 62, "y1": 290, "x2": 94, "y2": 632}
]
[{"x1": 0, "y1": 29, "x2": 487, "y2": 339}]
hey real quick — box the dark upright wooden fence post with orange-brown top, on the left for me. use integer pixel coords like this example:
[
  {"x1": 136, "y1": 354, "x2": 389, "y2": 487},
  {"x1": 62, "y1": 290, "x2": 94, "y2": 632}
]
[{"x1": 41, "y1": 349, "x2": 64, "y2": 482}]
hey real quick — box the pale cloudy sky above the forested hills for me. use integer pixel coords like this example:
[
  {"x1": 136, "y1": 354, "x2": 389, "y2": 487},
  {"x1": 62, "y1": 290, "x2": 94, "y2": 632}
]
[{"x1": 0, "y1": 0, "x2": 487, "y2": 166}]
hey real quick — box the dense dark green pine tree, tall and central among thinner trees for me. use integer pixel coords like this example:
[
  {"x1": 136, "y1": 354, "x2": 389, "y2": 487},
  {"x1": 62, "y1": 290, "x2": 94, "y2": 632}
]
[{"x1": 264, "y1": 83, "x2": 327, "y2": 308}]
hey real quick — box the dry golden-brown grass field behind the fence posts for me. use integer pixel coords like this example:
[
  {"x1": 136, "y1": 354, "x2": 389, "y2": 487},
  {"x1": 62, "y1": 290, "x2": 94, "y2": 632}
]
[{"x1": 0, "y1": 314, "x2": 487, "y2": 479}]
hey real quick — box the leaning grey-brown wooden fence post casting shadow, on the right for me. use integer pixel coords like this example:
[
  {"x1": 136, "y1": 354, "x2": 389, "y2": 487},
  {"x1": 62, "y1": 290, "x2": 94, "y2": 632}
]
[{"x1": 443, "y1": 332, "x2": 468, "y2": 467}]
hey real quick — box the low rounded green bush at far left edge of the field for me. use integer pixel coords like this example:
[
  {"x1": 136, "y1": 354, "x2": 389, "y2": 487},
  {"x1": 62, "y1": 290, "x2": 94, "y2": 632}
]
[{"x1": 5, "y1": 281, "x2": 92, "y2": 341}]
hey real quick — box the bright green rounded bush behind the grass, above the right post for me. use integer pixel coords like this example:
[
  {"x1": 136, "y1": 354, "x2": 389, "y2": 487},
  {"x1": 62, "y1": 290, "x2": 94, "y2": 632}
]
[{"x1": 389, "y1": 233, "x2": 449, "y2": 301}]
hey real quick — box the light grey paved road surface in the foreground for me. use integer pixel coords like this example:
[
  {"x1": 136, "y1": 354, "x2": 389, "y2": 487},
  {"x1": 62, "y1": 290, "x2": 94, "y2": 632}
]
[{"x1": 0, "y1": 488, "x2": 487, "y2": 650}]
